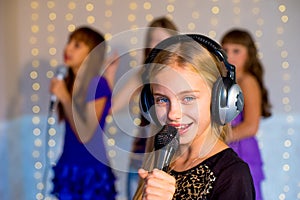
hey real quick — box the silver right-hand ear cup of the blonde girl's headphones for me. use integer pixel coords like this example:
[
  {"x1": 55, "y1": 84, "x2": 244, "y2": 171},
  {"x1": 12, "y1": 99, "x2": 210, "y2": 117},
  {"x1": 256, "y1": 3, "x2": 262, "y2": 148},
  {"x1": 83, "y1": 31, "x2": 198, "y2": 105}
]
[{"x1": 211, "y1": 77, "x2": 244, "y2": 125}]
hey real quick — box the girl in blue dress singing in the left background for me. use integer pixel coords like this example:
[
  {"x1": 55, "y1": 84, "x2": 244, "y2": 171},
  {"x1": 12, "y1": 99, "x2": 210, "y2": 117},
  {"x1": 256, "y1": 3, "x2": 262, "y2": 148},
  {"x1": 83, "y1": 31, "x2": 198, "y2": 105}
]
[{"x1": 50, "y1": 27, "x2": 116, "y2": 200}]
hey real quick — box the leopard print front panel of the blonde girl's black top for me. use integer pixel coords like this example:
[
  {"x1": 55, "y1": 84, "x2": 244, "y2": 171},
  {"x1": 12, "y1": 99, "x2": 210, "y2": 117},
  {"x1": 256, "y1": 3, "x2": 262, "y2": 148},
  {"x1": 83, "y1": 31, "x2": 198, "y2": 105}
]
[{"x1": 170, "y1": 164, "x2": 216, "y2": 200}]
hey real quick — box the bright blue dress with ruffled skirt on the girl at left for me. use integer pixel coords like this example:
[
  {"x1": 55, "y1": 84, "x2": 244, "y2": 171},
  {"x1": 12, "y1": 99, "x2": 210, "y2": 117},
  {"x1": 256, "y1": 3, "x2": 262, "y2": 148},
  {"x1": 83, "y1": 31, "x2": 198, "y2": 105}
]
[{"x1": 52, "y1": 76, "x2": 116, "y2": 200}]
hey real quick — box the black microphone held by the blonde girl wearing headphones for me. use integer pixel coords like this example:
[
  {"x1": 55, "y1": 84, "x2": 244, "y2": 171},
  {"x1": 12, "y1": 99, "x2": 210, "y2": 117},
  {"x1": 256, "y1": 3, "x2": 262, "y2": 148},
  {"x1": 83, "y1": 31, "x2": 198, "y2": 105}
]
[{"x1": 154, "y1": 125, "x2": 179, "y2": 172}]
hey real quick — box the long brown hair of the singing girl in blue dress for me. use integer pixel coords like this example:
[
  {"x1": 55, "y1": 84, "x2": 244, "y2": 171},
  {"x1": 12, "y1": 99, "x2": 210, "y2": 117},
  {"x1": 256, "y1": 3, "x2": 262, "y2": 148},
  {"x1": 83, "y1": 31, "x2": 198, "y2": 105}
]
[{"x1": 58, "y1": 26, "x2": 106, "y2": 121}]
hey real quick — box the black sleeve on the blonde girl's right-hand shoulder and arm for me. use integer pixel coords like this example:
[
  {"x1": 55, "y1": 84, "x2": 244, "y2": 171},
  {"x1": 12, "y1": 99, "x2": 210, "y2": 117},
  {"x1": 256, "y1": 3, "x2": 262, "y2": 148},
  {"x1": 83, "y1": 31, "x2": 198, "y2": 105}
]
[{"x1": 211, "y1": 162, "x2": 255, "y2": 200}]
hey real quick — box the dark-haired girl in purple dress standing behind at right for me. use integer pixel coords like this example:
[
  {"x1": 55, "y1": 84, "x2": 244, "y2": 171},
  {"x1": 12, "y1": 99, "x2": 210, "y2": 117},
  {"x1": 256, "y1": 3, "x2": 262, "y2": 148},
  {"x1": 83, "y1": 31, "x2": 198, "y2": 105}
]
[{"x1": 221, "y1": 29, "x2": 271, "y2": 200}]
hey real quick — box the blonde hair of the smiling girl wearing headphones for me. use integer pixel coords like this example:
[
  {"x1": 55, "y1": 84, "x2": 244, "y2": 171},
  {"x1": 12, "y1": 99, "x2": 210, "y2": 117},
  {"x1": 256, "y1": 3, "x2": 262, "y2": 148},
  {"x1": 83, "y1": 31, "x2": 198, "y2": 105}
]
[{"x1": 134, "y1": 38, "x2": 229, "y2": 199}]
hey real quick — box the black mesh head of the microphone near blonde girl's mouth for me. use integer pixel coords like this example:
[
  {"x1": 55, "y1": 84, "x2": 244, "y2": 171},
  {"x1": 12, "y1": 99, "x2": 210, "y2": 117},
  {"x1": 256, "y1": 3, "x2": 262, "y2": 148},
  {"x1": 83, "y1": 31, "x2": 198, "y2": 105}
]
[{"x1": 154, "y1": 125, "x2": 179, "y2": 150}]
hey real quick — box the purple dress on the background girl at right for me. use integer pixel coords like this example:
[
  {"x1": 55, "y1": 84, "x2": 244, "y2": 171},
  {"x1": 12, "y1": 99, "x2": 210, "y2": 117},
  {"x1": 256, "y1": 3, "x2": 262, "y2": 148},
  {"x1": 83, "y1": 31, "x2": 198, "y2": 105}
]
[{"x1": 229, "y1": 112, "x2": 265, "y2": 200}]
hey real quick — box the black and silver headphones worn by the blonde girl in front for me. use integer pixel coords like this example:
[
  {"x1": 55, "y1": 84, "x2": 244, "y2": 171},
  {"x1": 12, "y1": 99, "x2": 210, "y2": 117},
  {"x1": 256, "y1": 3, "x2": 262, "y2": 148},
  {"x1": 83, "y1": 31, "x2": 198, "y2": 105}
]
[{"x1": 140, "y1": 34, "x2": 244, "y2": 125}]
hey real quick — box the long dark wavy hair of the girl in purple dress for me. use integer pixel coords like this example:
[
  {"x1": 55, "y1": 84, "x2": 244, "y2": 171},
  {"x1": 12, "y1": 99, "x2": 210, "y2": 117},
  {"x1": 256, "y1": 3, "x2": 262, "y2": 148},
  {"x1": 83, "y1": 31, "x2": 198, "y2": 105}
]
[{"x1": 221, "y1": 29, "x2": 272, "y2": 118}]
